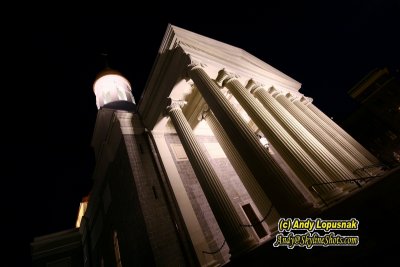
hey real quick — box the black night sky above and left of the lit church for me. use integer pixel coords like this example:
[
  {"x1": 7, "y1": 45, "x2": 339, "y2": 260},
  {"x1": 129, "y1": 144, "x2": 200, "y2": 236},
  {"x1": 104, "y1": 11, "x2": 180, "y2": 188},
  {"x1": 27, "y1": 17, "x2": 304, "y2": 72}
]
[{"x1": 2, "y1": 0, "x2": 400, "y2": 266}]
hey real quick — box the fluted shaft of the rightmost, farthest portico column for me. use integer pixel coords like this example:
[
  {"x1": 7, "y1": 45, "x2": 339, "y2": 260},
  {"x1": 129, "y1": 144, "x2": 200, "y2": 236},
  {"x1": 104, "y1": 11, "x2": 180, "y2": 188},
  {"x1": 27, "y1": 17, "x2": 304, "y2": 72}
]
[{"x1": 308, "y1": 103, "x2": 379, "y2": 163}]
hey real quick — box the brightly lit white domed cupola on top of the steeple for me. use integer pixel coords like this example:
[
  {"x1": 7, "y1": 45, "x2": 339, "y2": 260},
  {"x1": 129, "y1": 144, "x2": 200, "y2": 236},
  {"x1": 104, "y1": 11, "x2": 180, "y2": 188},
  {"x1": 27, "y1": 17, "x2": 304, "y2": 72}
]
[{"x1": 93, "y1": 68, "x2": 136, "y2": 110}]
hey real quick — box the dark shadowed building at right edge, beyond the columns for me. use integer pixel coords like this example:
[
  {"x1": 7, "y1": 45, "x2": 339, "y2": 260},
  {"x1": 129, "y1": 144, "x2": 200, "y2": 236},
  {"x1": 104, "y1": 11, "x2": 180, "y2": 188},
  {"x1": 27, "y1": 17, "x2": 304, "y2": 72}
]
[{"x1": 343, "y1": 68, "x2": 400, "y2": 166}]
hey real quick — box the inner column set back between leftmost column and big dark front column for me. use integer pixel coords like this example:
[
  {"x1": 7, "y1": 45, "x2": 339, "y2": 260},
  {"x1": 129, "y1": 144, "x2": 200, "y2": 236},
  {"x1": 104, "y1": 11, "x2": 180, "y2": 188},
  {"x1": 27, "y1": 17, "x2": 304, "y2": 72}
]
[{"x1": 202, "y1": 106, "x2": 279, "y2": 231}]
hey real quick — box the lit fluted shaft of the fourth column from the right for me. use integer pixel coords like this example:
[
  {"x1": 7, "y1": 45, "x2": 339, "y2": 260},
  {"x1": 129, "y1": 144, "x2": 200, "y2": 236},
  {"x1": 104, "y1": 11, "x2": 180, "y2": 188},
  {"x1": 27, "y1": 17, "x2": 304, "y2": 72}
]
[{"x1": 247, "y1": 80, "x2": 355, "y2": 180}]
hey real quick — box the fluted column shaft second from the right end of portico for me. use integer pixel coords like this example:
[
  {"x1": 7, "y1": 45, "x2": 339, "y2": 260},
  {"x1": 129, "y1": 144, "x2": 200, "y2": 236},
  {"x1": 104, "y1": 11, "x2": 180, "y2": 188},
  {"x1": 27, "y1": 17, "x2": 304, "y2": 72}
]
[{"x1": 293, "y1": 99, "x2": 372, "y2": 166}]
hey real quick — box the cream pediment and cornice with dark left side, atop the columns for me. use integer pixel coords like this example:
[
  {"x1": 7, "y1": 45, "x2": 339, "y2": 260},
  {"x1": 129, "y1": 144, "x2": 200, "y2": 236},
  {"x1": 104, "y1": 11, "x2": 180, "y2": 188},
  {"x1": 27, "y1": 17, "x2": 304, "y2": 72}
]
[{"x1": 138, "y1": 24, "x2": 301, "y2": 129}]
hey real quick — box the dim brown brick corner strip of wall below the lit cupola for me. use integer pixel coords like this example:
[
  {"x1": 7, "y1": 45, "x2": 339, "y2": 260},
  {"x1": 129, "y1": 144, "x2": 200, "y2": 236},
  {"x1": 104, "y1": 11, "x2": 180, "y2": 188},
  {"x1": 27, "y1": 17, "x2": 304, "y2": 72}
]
[{"x1": 124, "y1": 135, "x2": 184, "y2": 266}]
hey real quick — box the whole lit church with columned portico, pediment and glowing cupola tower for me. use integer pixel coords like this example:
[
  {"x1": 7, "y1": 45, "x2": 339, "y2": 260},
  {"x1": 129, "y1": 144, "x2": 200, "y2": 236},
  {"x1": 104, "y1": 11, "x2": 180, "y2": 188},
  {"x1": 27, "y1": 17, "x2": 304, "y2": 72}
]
[{"x1": 77, "y1": 25, "x2": 379, "y2": 266}]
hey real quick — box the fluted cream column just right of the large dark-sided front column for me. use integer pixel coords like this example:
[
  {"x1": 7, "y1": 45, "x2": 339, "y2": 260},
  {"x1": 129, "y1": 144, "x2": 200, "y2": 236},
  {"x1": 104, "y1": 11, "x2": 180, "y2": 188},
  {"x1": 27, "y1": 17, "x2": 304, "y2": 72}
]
[{"x1": 218, "y1": 70, "x2": 344, "y2": 197}]
